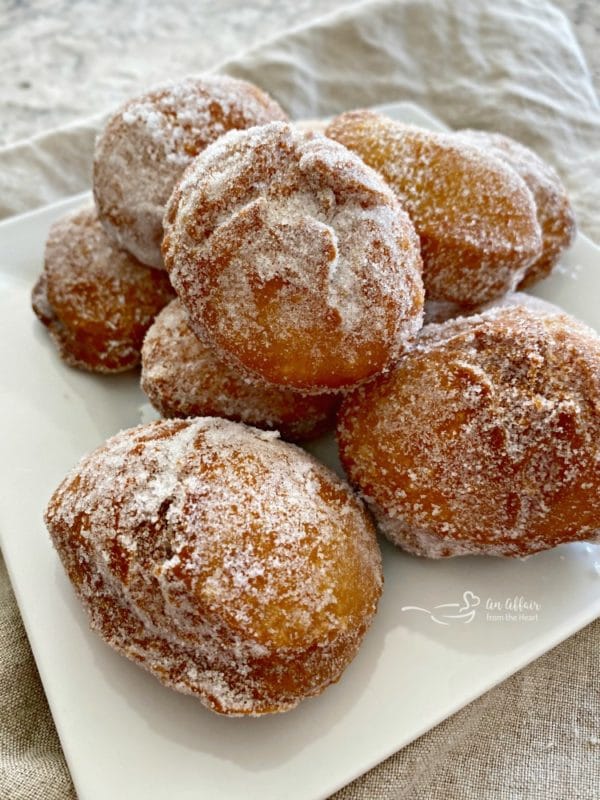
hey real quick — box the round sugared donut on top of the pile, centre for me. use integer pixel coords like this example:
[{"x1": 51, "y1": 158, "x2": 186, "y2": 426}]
[{"x1": 163, "y1": 122, "x2": 423, "y2": 393}]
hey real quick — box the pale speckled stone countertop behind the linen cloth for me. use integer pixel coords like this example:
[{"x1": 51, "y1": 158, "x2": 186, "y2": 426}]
[{"x1": 0, "y1": 0, "x2": 600, "y2": 145}]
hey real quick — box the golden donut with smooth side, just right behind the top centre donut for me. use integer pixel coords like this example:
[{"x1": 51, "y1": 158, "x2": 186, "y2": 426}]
[{"x1": 326, "y1": 111, "x2": 542, "y2": 306}]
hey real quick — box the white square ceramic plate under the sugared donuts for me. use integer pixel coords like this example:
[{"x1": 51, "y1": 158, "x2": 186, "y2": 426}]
[{"x1": 0, "y1": 112, "x2": 600, "y2": 800}]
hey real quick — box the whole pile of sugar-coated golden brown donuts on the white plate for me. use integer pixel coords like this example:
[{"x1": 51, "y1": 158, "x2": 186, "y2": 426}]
[{"x1": 38, "y1": 75, "x2": 600, "y2": 715}]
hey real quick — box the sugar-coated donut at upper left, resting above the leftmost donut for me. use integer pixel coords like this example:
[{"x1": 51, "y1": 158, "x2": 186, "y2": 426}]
[{"x1": 94, "y1": 75, "x2": 287, "y2": 268}]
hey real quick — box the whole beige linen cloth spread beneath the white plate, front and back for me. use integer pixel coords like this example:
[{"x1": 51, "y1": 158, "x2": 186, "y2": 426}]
[{"x1": 0, "y1": 0, "x2": 600, "y2": 800}]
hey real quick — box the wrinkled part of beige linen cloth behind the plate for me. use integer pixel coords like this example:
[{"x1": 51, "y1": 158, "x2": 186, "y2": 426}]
[{"x1": 0, "y1": 0, "x2": 600, "y2": 240}]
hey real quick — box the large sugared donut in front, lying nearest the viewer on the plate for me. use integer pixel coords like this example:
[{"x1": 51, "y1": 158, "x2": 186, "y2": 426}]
[{"x1": 45, "y1": 417, "x2": 382, "y2": 716}]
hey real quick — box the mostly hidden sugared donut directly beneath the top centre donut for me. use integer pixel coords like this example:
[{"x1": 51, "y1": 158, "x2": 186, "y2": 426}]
[{"x1": 142, "y1": 300, "x2": 339, "y2": 441}]
